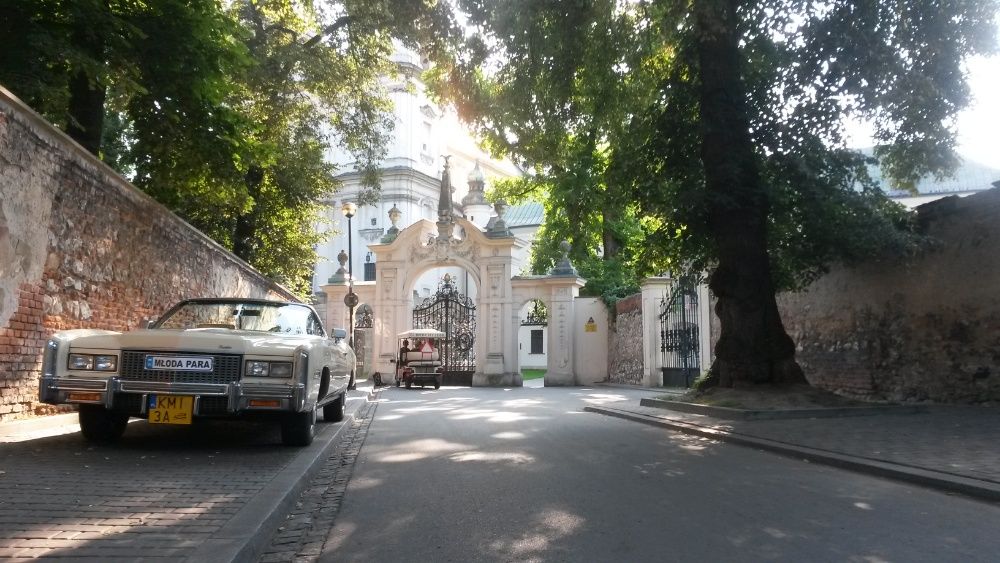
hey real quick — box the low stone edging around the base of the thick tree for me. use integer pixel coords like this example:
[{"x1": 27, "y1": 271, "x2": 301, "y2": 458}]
[{"x1": 639, "y1": 399, "x2": 927, "y2": 420}]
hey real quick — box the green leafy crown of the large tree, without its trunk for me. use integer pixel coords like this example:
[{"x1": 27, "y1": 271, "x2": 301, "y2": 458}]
[{"x1": 432, "y1": 0, "x2": 997, "y2": 296}]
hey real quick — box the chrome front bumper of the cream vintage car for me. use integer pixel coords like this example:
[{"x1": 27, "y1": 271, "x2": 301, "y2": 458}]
[{"x1": 38, "y1": 376, "x2": 306, "y2": 415}]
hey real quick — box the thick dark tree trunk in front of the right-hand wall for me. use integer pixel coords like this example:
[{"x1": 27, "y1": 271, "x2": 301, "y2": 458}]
[{"x1": 694, "y1": 0, "x2": 805, "y2": 387}]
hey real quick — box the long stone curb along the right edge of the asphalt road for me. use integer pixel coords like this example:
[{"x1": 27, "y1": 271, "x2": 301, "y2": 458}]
[{"x1": 583, "y1": 406, "x2": 1000, "y2": 502}]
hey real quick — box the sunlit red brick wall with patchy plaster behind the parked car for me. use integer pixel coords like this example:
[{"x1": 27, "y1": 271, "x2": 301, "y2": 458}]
[{"x1": 0, "y1": 88, "x2": 292, "y2": 421}]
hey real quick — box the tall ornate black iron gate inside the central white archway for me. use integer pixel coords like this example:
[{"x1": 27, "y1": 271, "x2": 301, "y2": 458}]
[{"x1": 413, "y1": 274, "x2": 476, "y2": 385}]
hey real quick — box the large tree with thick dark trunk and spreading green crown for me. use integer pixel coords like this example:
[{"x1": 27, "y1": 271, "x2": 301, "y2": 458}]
[{"x1": 436, "y1": 0, "x2": 997, "y2": 385}]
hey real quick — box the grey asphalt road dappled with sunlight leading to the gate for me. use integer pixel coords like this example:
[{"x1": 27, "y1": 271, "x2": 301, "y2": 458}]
[{"x1": 320, "y1": 387, "x2": 1000, "y2": 563}]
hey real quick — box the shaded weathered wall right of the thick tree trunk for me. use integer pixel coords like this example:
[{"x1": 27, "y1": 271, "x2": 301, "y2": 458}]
[{"x1": 779, "y1": 189, "x2": 1000, "y2": 403}]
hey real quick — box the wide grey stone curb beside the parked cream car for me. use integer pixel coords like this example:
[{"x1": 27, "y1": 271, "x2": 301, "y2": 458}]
[{"x1": 186, "y1": 389, "x2": 376, "y2": 563}]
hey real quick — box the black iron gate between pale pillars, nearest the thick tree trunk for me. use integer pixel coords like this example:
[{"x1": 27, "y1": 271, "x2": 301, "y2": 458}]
[{"x1": 660, "y1": 280, "x2": 701, "y2": 387}]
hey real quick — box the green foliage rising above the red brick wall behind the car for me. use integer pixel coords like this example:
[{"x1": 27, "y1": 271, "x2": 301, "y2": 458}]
[{"x1": 0, "y1": 0, "x2": 457, "y2": 296}]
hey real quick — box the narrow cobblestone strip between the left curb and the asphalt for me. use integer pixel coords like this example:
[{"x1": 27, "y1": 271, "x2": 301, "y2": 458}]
[{"x1": 258, "y1": 394, "x2": 378, "y2": 563}]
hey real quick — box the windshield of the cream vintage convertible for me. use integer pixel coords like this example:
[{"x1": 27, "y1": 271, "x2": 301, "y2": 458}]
[{"x1": 156, "y1": 301, "x2": 323, "y2": 335}]
